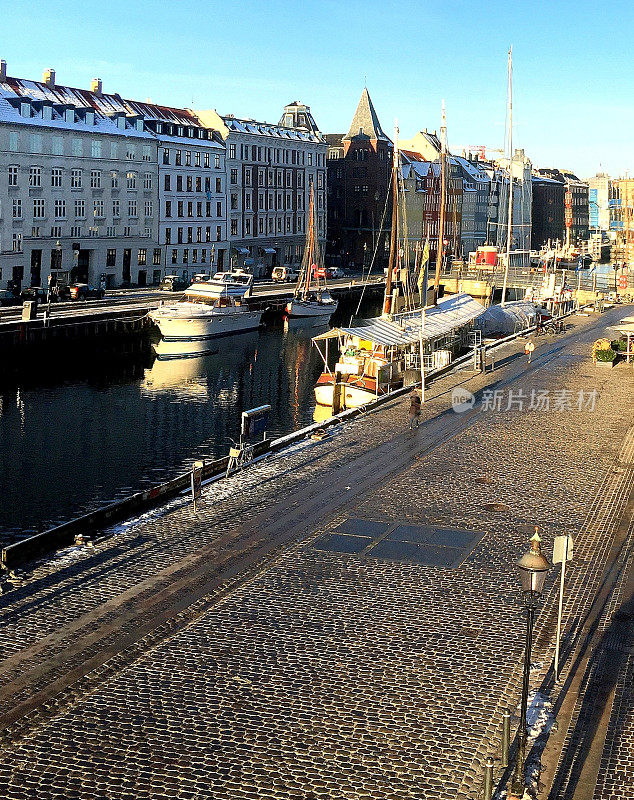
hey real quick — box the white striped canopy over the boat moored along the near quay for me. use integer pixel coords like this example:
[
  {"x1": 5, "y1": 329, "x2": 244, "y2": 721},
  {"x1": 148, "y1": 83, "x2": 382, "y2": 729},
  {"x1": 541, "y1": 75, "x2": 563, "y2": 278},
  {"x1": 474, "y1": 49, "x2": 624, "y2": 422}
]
[{"x1": 313, "y1": 293, "x2": 484, "y2": 347}]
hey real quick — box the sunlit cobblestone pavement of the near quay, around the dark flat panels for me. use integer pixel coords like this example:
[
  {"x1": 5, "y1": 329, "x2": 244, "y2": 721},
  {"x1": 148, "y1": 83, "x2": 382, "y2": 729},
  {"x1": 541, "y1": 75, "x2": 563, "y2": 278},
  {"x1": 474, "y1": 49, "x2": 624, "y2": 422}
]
[{"x1": 0, "y1": 309, "x2": 634, "y2": 800}]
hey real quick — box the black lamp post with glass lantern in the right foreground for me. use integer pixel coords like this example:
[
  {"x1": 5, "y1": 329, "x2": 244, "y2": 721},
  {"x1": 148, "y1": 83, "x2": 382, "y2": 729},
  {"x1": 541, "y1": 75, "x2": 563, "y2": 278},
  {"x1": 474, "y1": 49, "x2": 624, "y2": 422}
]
[{"x1": 508, "y1": 527, "x2": 550, "y2": 800}]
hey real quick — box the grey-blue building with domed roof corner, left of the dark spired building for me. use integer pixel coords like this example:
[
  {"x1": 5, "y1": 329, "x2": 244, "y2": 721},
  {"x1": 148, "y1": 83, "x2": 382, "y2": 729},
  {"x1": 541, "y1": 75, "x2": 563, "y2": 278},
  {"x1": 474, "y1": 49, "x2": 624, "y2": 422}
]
[{"x1": 196, "y1": 102, "x2": 328, "y2": 276}]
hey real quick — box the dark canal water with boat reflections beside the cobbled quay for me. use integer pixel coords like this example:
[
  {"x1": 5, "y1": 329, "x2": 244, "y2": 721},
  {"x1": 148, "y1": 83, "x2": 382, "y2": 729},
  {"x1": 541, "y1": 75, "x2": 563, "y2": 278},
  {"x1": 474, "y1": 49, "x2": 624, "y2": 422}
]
[{"x1": 0, "y1": 302, "x2": 378, "y2": 546}]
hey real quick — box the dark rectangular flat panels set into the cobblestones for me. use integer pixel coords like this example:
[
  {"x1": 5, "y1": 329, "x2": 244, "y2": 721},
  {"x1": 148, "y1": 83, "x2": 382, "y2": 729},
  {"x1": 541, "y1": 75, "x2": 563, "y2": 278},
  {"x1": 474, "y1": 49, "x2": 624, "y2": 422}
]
[{"x1": 313, "y1": 519, "x2": 484, "y2": 569}]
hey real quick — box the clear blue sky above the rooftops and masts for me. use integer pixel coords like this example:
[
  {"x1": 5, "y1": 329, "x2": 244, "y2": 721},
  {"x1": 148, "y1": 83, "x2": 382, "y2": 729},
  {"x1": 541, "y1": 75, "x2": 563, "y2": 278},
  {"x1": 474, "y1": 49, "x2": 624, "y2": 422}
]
[{"x1": 0, "y1": 0, "x2": 634, "y2": 177}]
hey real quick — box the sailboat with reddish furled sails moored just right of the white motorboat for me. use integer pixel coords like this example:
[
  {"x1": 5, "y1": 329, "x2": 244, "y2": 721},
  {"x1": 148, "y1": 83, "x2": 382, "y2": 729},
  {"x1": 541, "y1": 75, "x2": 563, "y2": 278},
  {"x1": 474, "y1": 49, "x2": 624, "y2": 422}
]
[{"x1": 286, "y1": 183, "x2": 338, "y2": 317}]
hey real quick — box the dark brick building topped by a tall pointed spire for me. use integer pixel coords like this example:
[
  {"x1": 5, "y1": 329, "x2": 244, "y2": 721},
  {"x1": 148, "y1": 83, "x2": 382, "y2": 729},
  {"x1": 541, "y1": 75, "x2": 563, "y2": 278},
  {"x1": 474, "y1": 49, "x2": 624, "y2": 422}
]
[{"x1": 326, "y1": 88, "x2": 393, "y2": 268}]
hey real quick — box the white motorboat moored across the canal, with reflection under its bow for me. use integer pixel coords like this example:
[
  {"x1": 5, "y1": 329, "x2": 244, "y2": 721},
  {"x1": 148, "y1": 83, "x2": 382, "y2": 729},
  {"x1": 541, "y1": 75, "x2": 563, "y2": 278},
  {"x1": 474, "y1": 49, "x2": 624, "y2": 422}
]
[{"x1": 149, "y1": 282, "x2": 262, "y2": 358}]
